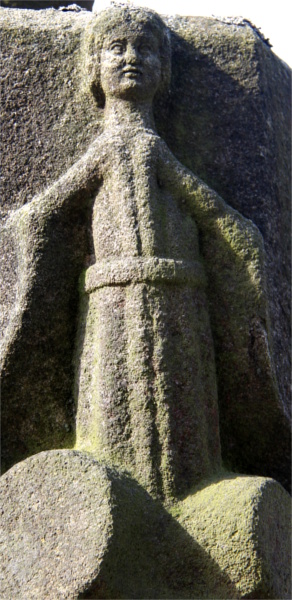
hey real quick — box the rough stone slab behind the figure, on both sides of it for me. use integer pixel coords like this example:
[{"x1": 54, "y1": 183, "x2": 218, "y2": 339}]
[{"x1": 1, "y1": 9, "x2": 290, "y2": 492}]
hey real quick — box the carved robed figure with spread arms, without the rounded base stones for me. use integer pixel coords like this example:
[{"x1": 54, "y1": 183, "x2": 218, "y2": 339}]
[{"x1": 1, "y1": 7, "x2": 290, "y2": 498}]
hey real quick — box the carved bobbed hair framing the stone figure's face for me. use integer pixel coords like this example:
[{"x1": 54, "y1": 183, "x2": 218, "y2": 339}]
[{"x1": 84, "y1": 6, "x2": 171, "y2": 106}]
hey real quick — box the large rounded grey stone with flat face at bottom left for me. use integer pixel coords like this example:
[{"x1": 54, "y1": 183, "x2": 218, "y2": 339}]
[{"x1": 0, "y1": 450, "x2": 169, "y2": 600}]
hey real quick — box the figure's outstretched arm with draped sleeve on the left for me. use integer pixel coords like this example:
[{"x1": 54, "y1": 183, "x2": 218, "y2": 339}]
[{"x1": 0, "y1": 138, "x2": 106, "y2": 361}]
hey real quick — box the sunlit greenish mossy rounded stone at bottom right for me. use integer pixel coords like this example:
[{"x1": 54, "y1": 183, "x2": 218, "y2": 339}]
[{"x1": 171, "y1": 474, "x2": 291, "y2": 598}]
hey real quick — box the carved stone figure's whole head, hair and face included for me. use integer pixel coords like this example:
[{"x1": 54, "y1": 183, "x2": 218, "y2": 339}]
[{"x1": 86, "y1": 6, "x2": 171, "y2": 105}]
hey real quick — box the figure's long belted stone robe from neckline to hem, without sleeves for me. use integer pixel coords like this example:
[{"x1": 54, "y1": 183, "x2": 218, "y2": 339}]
[{"x1": 76, "y1": 130, "x2": 221, "y2": 497}]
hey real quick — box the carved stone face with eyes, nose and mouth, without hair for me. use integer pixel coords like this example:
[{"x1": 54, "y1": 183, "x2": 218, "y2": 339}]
[{"x1": 100, "y1": 28, "x2": 161, "y2": 102}]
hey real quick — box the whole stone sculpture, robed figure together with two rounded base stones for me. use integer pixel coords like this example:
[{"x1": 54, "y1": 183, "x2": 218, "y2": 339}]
[{"x1": 2, "y1": 2, "x2": 289, "y2": 598}]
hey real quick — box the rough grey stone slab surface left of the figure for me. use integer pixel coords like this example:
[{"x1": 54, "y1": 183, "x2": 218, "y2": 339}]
[{"x1": 0, "y1": 9, "x2": 97, "y2": 468}]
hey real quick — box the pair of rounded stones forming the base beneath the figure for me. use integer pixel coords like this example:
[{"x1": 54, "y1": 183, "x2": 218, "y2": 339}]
[{"x1": 0, "y1": 450, "x2": 291, "y2": 600}]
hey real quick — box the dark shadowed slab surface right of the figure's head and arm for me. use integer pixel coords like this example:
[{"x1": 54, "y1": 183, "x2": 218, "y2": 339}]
[{"x1": 161, "y1": 17, "x2": 291, "y2": 488}]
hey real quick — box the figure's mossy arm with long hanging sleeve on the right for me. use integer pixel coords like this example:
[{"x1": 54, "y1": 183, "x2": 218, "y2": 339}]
[{"x1": 158, "y1": 143, "x2": 289, "y2": 480}]
